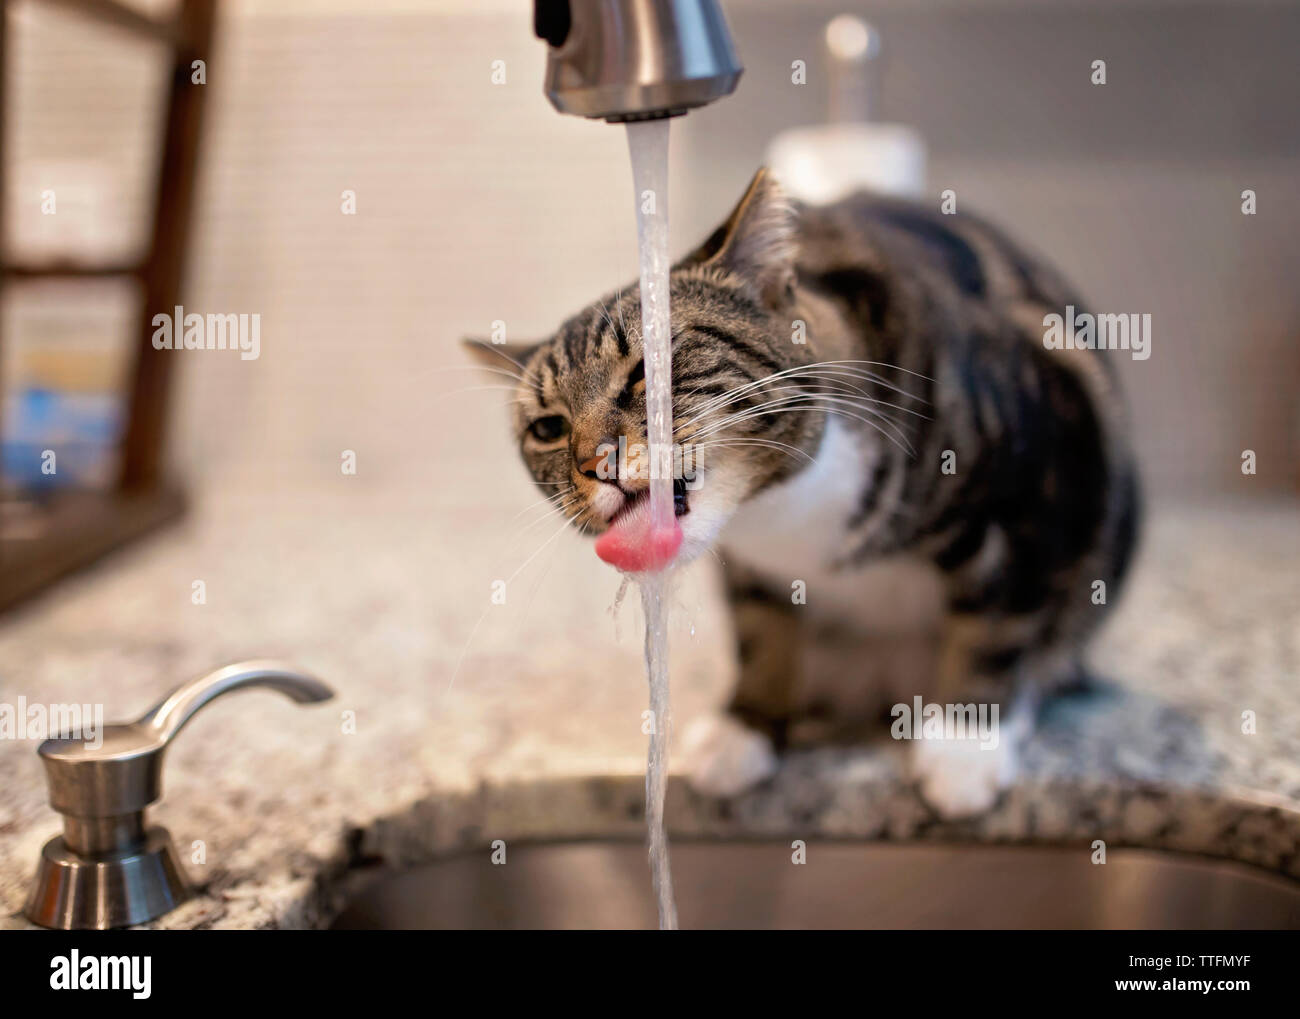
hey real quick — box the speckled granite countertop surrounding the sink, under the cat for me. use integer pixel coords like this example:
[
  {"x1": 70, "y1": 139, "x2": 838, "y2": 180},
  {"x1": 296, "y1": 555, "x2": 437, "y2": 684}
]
[{"x1": 0, "y1": 487, "x2": 1300, "y2": 928}]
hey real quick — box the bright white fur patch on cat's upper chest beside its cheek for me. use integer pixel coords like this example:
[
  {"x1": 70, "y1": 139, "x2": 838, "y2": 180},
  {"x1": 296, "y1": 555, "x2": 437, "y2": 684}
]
[{"x1": 722, "y1": 416, "x2": 879, "y2": 581}]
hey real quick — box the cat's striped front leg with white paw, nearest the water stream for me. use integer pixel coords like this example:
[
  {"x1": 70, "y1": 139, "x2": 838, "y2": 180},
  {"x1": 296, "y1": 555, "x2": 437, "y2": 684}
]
[{"x1": 681, "y1": 565, "x2": 801, "y2": 797}]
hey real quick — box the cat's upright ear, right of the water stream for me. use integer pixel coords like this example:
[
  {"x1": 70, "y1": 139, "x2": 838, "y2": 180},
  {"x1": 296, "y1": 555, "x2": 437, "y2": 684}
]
[{"x1": 680, "y1": 166, "x2": 797, "y2": 308}]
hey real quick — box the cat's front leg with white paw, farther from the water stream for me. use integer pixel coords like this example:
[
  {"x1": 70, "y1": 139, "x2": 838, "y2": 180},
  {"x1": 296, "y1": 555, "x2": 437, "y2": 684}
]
[{"x1": 911, "y1": 613, "x2": 1037, "y2": 818}]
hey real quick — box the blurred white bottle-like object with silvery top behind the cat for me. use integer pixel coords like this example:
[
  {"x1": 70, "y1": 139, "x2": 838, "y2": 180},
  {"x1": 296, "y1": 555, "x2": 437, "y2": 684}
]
[{"x1": 766, "y1": 14, "x2": 926, "y2": 204}]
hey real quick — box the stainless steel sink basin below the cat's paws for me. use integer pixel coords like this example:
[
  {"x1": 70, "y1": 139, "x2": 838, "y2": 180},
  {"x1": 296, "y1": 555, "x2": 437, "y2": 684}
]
[{"x1": 334, "y1": 841, "x2": 1300, "y2": 931}]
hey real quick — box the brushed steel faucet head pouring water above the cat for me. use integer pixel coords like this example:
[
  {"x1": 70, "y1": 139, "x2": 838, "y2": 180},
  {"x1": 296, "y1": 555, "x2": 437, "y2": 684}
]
[{"x1": 533, "y1": 0, "x2": 744, "y2": 122}]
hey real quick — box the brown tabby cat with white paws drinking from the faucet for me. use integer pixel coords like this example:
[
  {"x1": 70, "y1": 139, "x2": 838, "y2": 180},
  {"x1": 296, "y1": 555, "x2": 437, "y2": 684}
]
[{"x1": 467, "y1": 170, "x2": 1139, "y2": 818}]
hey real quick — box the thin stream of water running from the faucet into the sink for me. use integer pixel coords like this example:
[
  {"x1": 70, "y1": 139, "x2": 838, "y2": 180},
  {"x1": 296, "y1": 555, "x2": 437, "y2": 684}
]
[{"x1": 628, "y1": 120, "x2": 677, "y2": 931}]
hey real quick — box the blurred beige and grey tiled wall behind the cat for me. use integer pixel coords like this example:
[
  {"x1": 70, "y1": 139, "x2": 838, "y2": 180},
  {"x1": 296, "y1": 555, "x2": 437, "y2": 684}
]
[{"x1": 8, "y1": 0, "x2": 1300, "y2": 493}]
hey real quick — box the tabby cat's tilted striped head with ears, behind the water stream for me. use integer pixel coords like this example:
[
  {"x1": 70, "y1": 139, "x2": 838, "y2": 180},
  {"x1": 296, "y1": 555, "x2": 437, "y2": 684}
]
[{"x1": 467, "y1": 170, "x2": 822, "y2": 560}]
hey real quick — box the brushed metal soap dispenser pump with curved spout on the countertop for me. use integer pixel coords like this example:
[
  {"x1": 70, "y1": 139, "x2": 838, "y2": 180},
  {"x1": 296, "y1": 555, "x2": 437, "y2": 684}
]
[{"x1": 23, "y1": 660, "x2": 334, "y2": 931}]
